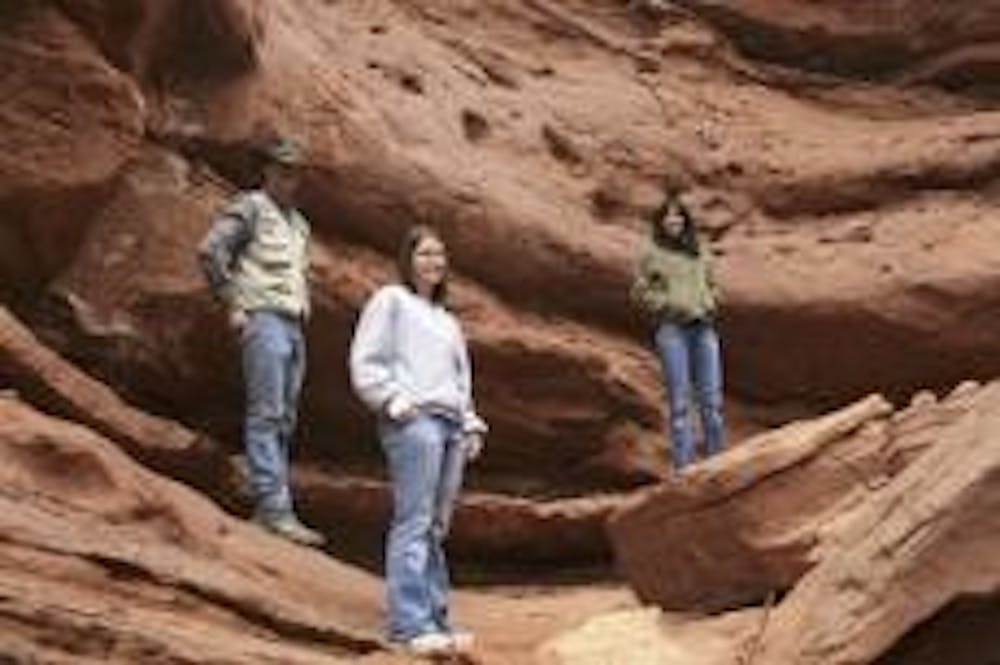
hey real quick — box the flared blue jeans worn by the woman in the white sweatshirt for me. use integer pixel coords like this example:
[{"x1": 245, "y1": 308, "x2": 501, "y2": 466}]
[{"x1": 380, "y1": 414, "x2": 465, "y2": 641}]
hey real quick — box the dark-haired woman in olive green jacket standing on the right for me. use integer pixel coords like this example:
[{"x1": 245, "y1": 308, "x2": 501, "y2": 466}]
[{"x1": 631, "y1": 191, "x2": 724, "y2": 470}]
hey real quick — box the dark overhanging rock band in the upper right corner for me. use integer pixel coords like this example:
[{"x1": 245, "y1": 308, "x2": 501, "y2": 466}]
[{"x1": 676, "y1": 0, "x2": 1000, "y2": 89}]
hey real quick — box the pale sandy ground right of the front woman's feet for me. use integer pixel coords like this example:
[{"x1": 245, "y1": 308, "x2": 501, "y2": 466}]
[{"x1": 359, "y1": 583, "x2": 766, "y2": 665}]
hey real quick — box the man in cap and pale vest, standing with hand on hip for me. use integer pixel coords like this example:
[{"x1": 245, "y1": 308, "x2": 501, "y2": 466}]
[{"x1": 199, "y1": 140, "x2": 324, "y2": 547}]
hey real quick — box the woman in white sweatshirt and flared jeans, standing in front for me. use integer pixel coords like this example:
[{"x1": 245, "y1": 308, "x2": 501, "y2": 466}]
[{"x1": 350, "y1": 226, "x2": 487, "y2": 654}]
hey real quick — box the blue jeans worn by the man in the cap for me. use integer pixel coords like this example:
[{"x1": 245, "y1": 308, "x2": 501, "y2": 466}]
[{"x1": 242, "y1": 311, "x2": 306, "y2": 516}]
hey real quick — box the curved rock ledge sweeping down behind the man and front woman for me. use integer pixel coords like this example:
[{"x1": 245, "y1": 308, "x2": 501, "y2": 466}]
[{"x1": 0, "y1": 308, "x2": 626, "y2": 567}]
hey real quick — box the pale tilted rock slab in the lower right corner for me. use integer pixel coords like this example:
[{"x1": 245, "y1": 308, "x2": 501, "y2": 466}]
[{"x1": 759, "y1": 384, "x2": 1000, "y2": 665}]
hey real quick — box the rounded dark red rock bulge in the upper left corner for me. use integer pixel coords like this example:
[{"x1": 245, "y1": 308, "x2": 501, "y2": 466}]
[{"x1": 0, "y1": 3, "x2": 146, "y2": 288}]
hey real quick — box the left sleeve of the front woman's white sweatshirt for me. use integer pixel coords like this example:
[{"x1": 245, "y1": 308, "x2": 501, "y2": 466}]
[{"x1": 349, "y1": 287, "x2": 405, "y2": 412}]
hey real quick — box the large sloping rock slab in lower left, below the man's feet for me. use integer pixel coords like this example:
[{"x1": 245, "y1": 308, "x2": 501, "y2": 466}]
[{"x1": 0, "y1": 397, "x2": 381, "y2": 664}]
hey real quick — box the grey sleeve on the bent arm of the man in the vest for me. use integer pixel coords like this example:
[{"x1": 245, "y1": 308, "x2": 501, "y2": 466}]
[{"x1": 198, "y1": 195, "x2": 255, "y2": 304}]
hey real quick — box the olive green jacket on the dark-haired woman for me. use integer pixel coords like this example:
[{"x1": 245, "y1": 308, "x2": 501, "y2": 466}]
[{"x1": 630, "y1": 240, "x2": 718, "y2": 322}]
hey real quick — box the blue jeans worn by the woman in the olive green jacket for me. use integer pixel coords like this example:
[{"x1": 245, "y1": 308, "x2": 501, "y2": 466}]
[{"x1": 655, "y1": 321, "x2": 724, "y2": 469}]
